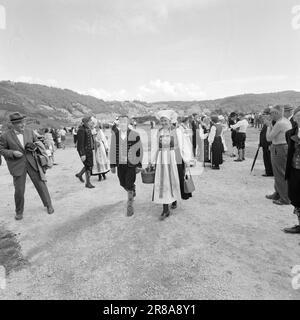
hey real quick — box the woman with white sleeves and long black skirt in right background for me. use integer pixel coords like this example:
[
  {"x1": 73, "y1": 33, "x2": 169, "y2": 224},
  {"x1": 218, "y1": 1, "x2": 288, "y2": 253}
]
[{"x1": 208, "y1": 115, "x2": 224, "y2": 170}]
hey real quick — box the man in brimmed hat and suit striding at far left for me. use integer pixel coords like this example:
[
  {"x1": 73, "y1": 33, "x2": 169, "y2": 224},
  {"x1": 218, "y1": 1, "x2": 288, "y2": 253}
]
[{"x1": 0, "y1": 112, "x2": 54, "y2": 220}]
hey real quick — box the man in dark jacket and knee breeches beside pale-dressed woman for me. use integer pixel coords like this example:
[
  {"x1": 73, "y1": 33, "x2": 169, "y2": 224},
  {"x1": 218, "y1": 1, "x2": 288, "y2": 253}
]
[{"x1": 75, "y1": 116, "x2": 95, "y2": 189}]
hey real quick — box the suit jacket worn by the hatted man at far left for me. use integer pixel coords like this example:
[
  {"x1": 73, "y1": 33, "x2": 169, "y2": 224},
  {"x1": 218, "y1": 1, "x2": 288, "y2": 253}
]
[{"x1": 0, "y1": 128, "x2": 38, "y2": 177}]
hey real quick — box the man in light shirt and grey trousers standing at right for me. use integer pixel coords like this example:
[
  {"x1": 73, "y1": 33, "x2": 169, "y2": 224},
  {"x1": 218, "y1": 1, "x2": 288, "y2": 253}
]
[{"x1": 266, "y1": 105, "x2": 292, "y2": 205}]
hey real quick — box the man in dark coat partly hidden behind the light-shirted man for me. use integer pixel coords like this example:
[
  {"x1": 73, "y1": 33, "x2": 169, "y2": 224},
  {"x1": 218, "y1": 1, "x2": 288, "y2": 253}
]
[{"x1": 259, "y1": 107, "x2": 273, "y2": 177}]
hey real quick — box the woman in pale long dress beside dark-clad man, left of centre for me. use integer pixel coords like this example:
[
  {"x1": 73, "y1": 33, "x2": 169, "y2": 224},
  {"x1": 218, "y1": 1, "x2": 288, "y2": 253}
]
[{"x1": 92, "y1": 121, "x2": 110, "y2": 181}]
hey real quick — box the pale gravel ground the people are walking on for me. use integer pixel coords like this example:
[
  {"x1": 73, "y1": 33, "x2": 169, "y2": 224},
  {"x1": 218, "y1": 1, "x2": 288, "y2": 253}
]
[{"x1": 0, "y1": 128, "x2": 300, "y2": 299}]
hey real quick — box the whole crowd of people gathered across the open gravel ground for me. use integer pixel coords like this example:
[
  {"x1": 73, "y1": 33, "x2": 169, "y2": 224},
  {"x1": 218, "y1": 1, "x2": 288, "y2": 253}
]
[{"x1": 0, "y1": 105, "x2": 300, "y2": 233}]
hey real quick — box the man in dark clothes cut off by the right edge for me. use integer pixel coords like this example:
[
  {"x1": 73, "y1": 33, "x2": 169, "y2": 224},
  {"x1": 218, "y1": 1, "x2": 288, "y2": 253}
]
[{"x1": 284, "y1": 107, "x2": 300, "y2": 234}]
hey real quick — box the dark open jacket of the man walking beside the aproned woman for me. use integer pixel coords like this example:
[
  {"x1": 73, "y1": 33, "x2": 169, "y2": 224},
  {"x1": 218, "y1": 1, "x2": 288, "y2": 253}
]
[{"x1": 110, "y1": 129, "x2": 143, "y2": 168}]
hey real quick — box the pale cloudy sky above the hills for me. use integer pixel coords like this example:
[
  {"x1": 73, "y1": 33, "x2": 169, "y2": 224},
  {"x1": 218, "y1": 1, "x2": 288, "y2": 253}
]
[{"x1": 0, "y1": 0, "x2": 300, "y2": 101}]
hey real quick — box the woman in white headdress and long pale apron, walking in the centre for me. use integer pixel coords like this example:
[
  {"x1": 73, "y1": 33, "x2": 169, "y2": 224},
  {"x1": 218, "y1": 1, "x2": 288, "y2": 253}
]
[{"x1": 151, "y1": 110, "x2": 192, "y2": 220}]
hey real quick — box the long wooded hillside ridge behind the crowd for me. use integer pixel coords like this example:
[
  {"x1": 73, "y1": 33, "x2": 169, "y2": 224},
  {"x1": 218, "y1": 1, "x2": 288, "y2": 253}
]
[{"x1": 0, "y1": 81, "x2": 300, "y2": 126}]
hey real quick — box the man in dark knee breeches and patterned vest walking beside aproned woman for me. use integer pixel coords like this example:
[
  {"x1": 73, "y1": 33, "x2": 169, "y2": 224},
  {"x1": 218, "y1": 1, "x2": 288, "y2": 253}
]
[{"x1": 110, "y1": 115, "x2": 143, "y2": 216}]
